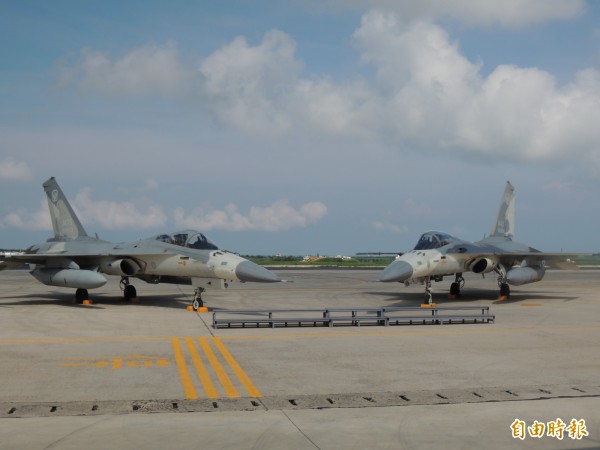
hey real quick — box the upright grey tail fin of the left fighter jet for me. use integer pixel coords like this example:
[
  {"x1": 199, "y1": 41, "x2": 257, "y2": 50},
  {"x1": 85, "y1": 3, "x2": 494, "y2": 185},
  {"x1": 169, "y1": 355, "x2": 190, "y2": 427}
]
[{"x1": 43, "y1": 177, "x2": 87, "y2": 239}]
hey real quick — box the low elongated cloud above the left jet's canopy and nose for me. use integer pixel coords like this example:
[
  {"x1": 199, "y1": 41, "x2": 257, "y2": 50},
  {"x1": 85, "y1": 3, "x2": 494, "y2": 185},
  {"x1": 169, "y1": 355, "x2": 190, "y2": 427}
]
[{"x1": 175, "y1": 200, "x2": 327, "y2": 231}]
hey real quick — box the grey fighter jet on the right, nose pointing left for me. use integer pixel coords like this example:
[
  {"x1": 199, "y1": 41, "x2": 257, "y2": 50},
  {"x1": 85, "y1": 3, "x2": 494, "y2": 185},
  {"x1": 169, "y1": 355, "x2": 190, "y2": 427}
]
[{"x1": 379, "y1": 182, "x2": 581, "y2": 305}]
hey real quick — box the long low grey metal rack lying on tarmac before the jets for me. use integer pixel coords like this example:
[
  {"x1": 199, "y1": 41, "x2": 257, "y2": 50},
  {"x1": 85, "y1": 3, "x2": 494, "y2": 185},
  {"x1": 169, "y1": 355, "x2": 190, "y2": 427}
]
[{"x1": 213, "y1": 306, "x2": 495, "y2": 328}]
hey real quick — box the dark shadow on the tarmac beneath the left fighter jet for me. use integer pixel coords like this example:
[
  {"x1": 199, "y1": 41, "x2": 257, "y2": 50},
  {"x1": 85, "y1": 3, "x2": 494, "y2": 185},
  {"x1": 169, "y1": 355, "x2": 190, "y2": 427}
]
[{"x1": 0, "y1": 292, "x2": 191, "y2": 310}]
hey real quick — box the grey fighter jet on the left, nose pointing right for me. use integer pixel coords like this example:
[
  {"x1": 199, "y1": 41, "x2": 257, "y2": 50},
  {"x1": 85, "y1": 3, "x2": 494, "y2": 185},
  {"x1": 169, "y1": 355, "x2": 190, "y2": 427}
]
[{"x1": 0, "y1": 177, "x2": 281, "y2": 311}]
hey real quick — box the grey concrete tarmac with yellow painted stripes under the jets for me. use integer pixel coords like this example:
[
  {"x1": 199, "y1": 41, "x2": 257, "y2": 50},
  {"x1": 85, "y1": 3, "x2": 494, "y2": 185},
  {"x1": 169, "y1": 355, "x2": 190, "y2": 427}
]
[{"x1": 0, "y1": 269, "x2": 600, "y2": 449}]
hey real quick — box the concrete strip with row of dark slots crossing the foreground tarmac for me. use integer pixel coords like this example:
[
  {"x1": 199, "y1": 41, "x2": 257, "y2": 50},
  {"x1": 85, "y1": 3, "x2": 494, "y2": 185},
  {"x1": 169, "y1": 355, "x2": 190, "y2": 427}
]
[{"x1": 0, "y1": 385, "x2": 600, "y2": 418}]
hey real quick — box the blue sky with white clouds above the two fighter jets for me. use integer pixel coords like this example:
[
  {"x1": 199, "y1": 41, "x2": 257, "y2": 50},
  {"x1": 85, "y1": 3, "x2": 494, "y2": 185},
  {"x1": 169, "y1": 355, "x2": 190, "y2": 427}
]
[{"x1": 0, "y1": 0, "x2": 600, "y2": 255}]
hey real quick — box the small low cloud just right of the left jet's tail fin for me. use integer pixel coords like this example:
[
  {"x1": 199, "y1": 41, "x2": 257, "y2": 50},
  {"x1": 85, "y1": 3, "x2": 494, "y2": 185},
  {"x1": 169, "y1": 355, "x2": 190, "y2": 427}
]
[{"x1": 73, "y1": 188, "x2": 167, "y2": 229}]
